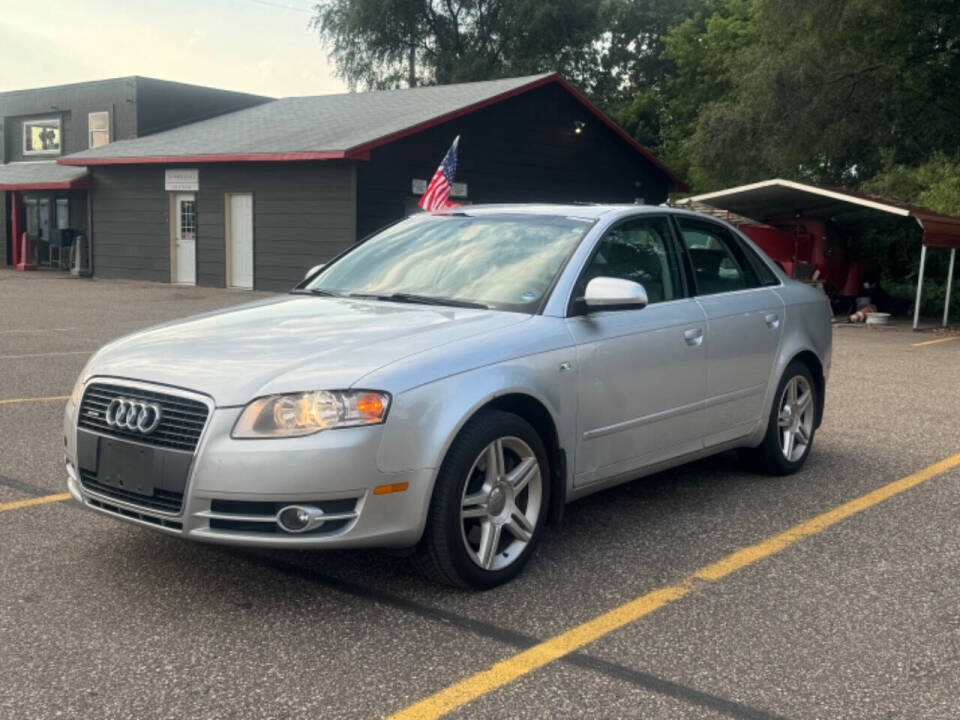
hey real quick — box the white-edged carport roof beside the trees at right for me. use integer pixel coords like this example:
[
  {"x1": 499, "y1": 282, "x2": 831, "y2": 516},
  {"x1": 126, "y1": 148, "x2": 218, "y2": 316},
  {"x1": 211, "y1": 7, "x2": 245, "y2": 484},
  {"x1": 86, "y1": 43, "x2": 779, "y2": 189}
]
[{"x1": 680, "y1": 179, "x2": 960, "y2": 248}]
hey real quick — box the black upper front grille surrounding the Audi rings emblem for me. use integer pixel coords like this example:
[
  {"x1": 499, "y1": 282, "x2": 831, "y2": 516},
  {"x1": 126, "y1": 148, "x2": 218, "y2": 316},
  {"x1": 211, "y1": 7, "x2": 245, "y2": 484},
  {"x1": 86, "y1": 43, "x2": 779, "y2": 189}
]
[{"x1": 77, "y1": 383, "x2": 208, "y2": 452}]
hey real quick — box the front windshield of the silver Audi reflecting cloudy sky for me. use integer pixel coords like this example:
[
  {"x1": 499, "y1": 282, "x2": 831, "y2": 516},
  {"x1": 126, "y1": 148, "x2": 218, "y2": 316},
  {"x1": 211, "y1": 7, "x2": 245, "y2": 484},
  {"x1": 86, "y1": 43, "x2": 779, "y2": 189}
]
[{"x1": 304, "y1": 213, "x2": 593, "y2": 312}]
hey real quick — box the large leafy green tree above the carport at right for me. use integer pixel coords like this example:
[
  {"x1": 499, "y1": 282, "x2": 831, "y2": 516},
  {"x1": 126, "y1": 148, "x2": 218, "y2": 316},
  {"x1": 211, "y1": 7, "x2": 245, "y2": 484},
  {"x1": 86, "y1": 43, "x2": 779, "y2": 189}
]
[{"x1": 664, "y1": 0, "x2": 960, "y2": 189}]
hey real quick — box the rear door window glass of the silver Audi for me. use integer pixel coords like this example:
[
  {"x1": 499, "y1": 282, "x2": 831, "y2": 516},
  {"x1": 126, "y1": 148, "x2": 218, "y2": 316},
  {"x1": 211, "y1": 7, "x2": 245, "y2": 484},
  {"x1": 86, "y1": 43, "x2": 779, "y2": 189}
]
[{"x1": 677, "y1": 217, "x2": 760, "y2": 295}]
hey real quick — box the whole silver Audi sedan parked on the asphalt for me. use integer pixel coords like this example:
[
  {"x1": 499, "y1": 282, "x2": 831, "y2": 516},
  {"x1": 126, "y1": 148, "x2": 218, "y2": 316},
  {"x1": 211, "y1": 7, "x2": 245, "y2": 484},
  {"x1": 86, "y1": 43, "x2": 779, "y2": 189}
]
[{"x1": 64, "y1": 205, "x2": 831, "y2": 588}]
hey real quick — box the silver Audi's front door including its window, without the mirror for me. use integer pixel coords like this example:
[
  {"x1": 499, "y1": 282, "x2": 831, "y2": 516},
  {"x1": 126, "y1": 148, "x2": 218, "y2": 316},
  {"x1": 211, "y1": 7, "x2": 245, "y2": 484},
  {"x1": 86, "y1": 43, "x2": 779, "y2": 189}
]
[{"x1": 568, "y1": 216, "x2": 706, "y2": 485}]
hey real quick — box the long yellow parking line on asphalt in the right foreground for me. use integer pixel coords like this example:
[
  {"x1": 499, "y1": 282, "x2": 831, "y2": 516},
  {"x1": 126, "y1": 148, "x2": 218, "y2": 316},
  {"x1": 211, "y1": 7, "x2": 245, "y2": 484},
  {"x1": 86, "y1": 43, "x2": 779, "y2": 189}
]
[{"x1": 388, "y1": 453, "x2": 960, "y2": 720}]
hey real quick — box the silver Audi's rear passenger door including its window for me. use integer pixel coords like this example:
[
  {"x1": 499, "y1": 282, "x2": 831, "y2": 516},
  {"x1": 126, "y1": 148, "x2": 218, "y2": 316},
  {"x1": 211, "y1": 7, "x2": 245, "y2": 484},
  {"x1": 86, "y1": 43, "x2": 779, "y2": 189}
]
[{"x1": 676, "y1": 216, "x2": 784, "y2": 447}]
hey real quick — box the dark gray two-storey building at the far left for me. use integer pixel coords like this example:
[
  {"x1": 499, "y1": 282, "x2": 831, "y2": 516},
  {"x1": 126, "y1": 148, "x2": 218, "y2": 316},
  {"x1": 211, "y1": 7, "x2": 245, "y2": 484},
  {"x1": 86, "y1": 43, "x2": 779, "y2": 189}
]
[{"x1": 0, "y1": 77, "x2": 269, "y2": 265}]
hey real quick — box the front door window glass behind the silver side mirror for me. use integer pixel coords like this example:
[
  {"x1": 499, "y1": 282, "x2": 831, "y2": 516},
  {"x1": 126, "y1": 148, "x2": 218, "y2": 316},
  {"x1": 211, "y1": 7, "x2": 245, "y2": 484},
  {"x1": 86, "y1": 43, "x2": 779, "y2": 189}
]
[{"x1": 574, "y1": 217, "x2": 683, "y2": 304}]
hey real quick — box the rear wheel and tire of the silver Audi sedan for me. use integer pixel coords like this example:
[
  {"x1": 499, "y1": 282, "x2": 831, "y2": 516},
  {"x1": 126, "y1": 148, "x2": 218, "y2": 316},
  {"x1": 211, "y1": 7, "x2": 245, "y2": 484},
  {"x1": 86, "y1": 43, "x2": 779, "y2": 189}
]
[{"x1": 744, "y1": 360, "x2": 821, "y2": 476}]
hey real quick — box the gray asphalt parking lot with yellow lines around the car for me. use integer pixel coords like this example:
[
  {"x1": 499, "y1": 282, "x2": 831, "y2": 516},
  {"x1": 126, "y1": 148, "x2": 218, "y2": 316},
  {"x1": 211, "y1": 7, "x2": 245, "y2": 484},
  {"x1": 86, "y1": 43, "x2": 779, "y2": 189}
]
[{"x1": 0, "y1": 270, "x2": 960, "y2": 719}]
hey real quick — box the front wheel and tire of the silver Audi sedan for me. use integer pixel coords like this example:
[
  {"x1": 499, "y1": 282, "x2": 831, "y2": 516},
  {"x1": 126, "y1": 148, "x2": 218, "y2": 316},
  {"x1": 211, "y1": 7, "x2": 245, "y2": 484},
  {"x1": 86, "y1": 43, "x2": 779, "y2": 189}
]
[{"x1": 411, "y1": 410, "x2": 550, "y2": 590}]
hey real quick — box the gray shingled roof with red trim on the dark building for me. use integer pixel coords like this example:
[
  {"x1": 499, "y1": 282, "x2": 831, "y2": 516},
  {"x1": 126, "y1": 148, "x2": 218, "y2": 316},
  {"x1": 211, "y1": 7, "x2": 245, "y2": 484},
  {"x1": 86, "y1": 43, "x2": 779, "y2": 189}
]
[{"x1": 58, "y1": 73, "x2": 682, "y2": 187}]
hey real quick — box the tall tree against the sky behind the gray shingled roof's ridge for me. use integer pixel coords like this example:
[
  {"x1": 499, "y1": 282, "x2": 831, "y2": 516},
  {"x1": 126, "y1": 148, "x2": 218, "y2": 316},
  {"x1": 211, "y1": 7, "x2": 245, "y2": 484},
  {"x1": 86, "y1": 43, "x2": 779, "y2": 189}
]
[{"x1": 311, "y1": 0, "x2": 603, "y2": 88}]
